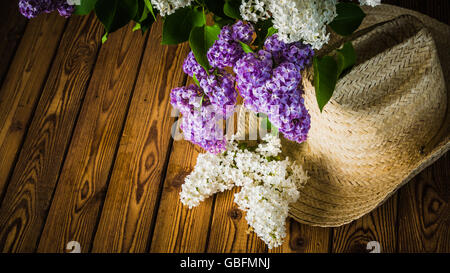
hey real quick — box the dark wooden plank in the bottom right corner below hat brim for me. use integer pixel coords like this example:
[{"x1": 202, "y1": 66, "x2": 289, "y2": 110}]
[{"x1": 398, "y1": 153, "x2": 450, "y2": 253}]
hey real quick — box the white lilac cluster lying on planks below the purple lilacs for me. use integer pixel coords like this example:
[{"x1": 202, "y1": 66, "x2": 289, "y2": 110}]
[{"x1": 180, "y1": 134, "x2": 307, "y2": 248}]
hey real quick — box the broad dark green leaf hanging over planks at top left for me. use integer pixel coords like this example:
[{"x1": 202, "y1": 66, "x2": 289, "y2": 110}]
[{"x1": 95, "y1": 0, "x2": 138, "y2": 33}]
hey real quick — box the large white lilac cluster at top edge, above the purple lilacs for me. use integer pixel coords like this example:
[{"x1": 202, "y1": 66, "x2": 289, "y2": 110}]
[{"x1": 240, "y1": 0, "x2": 380, "y2": 49}]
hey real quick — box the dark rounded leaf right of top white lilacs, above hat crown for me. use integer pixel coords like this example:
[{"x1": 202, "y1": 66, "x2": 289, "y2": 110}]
[{"x1": 330, "y1": 3, "x2": 366, "y2": 36}]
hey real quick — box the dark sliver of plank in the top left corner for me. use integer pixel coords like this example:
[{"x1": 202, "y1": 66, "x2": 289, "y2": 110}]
[{"x1": 0, "y1": 1, "x2": 27, "y2": 85}]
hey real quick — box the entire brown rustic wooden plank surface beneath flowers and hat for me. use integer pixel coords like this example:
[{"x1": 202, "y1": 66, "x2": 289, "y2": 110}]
[{"x1": 0, "y1": 0, "x2": 450, "y2": 253}]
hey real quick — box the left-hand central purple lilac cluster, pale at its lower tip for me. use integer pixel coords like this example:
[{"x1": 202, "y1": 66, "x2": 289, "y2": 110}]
[{"x1": 171, "y1": 21, "x2": 253, "y2": 154}]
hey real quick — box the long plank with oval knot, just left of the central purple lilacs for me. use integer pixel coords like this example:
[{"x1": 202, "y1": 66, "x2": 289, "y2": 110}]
[{"x1": 92, "y1": 19, "x2": 189, "y2": 252}]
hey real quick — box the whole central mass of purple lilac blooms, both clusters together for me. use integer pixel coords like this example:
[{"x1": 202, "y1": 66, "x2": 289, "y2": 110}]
[{"x1": 171, "y1": 21, "x2": 314, "y2": 153}]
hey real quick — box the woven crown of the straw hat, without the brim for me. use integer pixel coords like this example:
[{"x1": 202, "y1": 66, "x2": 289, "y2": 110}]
[{"x1": 298, "y1": 15, "x2": 447, "y2": 189}]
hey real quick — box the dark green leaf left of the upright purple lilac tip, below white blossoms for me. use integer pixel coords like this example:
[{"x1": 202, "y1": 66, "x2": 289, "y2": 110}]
[{"x1": 162, "y1": 7, "x2": 206, "y2": 45}]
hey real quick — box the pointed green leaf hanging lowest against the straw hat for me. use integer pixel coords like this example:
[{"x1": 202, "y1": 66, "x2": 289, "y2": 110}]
[{"x1": 313, "y1": 56, "x2": 338, "y2": 111}]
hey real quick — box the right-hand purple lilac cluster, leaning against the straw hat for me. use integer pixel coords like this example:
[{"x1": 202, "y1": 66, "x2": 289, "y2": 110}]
[{"x1": 234, "y1": 34, "x2": 314, "y2": 142}]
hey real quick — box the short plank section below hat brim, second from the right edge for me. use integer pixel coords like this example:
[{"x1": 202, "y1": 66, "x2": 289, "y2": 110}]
[{"x1": 332, "y1": 193, "x2": 397, "y2": 253}]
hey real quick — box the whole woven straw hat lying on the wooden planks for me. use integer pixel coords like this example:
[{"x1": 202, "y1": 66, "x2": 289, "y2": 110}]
[{"x1": 238, "y1": 5, "x2": 450, "y2": 227}]
